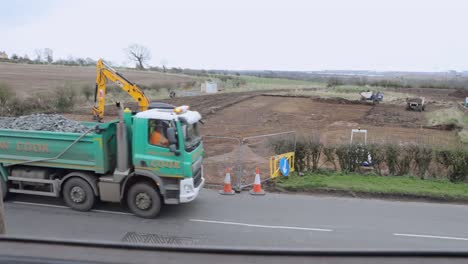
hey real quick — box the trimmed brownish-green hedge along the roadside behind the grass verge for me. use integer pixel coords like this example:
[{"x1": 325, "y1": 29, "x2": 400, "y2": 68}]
[{"x1": 271, "y1": 136, "x2": 468, "y2": 182}]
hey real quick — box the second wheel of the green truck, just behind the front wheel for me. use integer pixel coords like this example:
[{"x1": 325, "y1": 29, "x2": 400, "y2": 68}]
[{"x1": 62, "y1": 178, "x2": 96, "y2": 211}]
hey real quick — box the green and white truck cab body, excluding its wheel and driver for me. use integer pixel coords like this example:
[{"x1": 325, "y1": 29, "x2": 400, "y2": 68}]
[{"x1": 131, "y1": 106, "x2": 204, "y2": 204}]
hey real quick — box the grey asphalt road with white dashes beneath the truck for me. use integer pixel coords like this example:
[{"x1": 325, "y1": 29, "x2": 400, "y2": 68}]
[{"x1": 5, "y1": 189, "x2": 468, "y2": 250}]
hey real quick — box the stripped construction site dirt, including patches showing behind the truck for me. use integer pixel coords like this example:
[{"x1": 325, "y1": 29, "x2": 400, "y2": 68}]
[{"x1": 66, "y1": 91, "x2": 459, "y2": 184}]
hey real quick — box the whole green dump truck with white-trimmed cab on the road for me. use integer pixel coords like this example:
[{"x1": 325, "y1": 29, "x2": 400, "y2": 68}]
[{"x1": 0, "y1": 107, "x2": 204, "y2": 218}]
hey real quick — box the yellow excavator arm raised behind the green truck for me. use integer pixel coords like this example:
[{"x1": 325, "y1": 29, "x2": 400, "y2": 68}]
[{"x1": 93, "y1": 59, "x2": 150, "y2": 121}]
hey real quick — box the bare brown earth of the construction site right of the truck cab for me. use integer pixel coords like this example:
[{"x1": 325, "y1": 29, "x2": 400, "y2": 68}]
[{"x1": 193, "y1": 95, "x2": 458, "y2": 183}]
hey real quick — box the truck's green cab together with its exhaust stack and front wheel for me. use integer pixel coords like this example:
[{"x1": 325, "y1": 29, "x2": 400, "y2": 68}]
[{"x1": 106, "y1": 106, "x2": 205, "y2": 218}]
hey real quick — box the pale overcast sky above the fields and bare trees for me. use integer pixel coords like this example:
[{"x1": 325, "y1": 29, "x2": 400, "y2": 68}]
[{"x1": 0, "y1": 0, "x2": 468, "y2": 71}]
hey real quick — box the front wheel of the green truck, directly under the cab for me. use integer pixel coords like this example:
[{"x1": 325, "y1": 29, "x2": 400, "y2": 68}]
[{"x1": 127, "y1": 182, "x2": 161, "y2": 218}]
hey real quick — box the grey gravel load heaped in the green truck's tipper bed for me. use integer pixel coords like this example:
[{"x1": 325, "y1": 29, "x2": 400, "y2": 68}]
[{"x1": 0, "y1": 114, "x2": 89, "y2": 133}]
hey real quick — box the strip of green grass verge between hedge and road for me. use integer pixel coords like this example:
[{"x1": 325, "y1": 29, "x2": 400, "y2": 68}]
[{"x1": 275, "y1": 173, "x2": 468, "y2": 199}]
